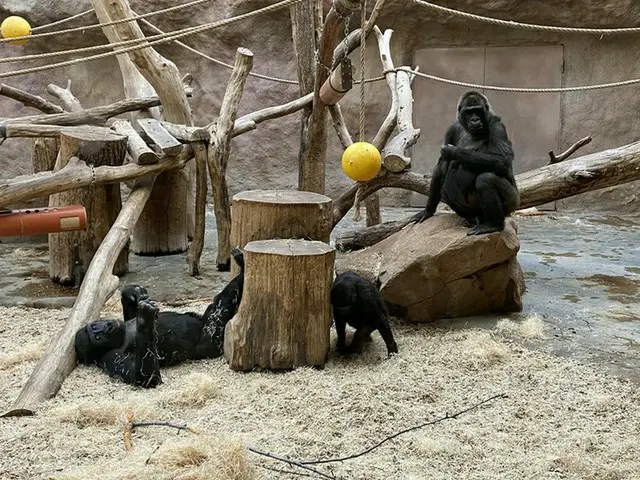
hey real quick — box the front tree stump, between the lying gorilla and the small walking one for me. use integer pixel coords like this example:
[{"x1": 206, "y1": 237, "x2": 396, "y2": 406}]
[{"x1": 224, "y1": 239, "x2": 335, "y2": 371}]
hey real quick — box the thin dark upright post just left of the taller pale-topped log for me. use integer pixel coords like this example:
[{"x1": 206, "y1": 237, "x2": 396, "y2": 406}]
[{"x1": 187, "y1": 142, "x2": 207, "y2": 277}]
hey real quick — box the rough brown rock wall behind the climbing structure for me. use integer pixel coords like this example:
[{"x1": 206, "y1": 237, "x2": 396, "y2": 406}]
[{"x1": 0, "y1": 0, "x2": 640, "y2": 211}]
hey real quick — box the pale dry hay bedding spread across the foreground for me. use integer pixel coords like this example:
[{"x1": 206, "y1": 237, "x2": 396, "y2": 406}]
[{"x1": 0, "y1": 304, "x2": 640, "y2": 480}]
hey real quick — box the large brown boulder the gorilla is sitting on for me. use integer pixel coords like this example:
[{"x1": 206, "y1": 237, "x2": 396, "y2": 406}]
[{"x1": 336, "y1": 213, "x2": 525, "y2": 322}]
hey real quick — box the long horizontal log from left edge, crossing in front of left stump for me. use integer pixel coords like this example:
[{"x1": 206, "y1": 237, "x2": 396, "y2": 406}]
[{"x1": 0, "y1": 146, "x2": 193, "y2": 207}]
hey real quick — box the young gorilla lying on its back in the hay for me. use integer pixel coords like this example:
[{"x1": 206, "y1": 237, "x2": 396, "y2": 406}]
[{"x1": 75, "y1": 248, "x2": 244, "y2": 388}]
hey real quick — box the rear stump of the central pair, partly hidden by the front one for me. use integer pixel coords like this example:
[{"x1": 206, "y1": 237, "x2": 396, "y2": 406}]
[{"x1": 231, "y1": 190, "x2": 333, "y2": 277}]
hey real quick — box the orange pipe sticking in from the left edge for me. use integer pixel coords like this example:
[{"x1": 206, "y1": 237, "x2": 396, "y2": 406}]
[{"x1": 0, "y1": 205, "x2": 87, "y2": 237}]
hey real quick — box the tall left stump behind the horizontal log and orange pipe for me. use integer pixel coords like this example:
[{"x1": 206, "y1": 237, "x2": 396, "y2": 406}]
[{"x1": 49, "y1": 127, "x2": 129, "y2": 285}]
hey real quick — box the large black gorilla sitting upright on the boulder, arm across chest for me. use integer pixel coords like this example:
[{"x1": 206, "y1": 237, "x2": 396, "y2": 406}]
[{"x1": 414, "y1": 91, "x2": 520, "y2": 235}]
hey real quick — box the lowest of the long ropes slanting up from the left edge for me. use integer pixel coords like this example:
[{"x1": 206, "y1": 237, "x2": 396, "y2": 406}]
[{"x1": 0, "y1": 0, "x2": 302, "y2": 78}]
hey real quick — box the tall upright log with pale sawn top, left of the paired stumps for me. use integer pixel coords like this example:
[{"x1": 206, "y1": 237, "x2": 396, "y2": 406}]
[{"x1": 207, "y1": 48, "x2": 253, "y2": 272}]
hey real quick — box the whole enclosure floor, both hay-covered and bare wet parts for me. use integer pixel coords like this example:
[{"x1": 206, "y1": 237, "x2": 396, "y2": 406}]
[{"x1": 0, "y1": 209, "x2": 640, "y2": 480}]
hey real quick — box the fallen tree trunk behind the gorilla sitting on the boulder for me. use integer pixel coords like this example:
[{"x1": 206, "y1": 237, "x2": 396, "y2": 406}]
[{"x1": 334, "y1": 142, "x2": 640, "y2": 251}]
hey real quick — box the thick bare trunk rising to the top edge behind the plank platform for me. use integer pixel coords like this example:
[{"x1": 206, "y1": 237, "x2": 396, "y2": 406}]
[{"x1": 93, "y1": 0, "x2": 195, "y2": 255}]
